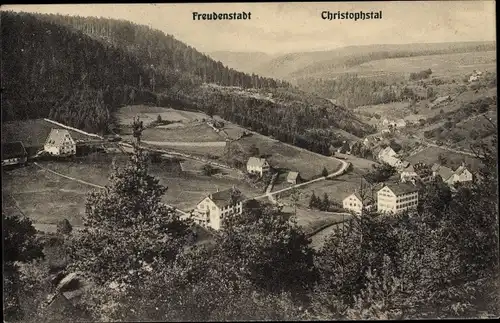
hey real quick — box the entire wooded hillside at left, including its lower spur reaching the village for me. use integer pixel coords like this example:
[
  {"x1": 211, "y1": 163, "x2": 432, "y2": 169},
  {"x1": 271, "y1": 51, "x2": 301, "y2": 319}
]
[{"x1": 2, "y1": 12, "x2": 374, "y2": 153}]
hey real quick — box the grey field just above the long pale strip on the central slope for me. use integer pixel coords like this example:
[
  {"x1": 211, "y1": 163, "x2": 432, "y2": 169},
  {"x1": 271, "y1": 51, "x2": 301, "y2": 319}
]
[{"x1": 142, "y1": 123, "x2": 225, "y2": 142}]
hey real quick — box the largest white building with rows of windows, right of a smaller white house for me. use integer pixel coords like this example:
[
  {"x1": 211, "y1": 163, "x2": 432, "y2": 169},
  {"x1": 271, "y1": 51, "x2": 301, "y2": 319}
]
[{"x1": 377, "y1": 183, "x2": 418, "y2": 213}]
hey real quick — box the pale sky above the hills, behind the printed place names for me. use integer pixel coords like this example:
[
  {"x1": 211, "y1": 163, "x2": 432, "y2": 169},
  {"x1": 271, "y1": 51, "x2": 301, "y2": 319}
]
[{"x1": 2, "y1": 1, "x2": 496, "y2": 54}]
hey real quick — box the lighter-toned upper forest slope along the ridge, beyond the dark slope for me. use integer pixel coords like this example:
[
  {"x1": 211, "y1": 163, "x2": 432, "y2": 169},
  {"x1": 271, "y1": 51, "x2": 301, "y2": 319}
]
[{"x1": 40, "y1": 15, "x2": 286, "y2": 92}]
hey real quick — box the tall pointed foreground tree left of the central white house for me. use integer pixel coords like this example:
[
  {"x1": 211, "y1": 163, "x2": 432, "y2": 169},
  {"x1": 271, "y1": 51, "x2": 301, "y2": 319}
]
[{"x1": 71, "y1": 148, "x2": 191, "y2": 285}]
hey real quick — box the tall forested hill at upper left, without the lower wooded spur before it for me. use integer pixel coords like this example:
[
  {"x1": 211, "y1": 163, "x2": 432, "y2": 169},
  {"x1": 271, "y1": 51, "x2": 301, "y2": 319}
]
[{"x1": 2, "y1": 12, "x2": 287, "y2": 132}]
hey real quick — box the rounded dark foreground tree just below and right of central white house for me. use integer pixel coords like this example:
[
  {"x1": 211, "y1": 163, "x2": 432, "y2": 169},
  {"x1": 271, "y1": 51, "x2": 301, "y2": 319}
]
[{"x1": 216, "y1": 207, "x2": 317, "y2": 295}]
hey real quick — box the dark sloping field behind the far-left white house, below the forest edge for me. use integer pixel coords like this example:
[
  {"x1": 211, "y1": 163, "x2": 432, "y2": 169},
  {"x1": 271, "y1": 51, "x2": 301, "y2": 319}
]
[{"x1": 2, "y1": 119, "x2": 96, "y2": 147}]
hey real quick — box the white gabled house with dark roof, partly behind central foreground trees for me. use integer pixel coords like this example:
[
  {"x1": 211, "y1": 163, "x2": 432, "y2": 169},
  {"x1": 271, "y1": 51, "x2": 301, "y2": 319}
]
[{"x1": 193, "y1": 187, "x2": 243, "y2": 230}]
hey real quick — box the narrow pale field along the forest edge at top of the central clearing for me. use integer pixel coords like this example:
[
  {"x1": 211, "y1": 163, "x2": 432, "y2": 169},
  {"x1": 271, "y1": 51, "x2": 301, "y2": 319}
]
[{"x1": 116, "y1": 105, "x2": 209, "y2": 125}]
